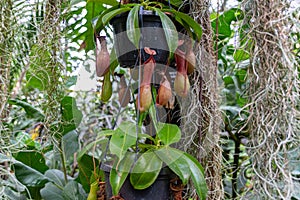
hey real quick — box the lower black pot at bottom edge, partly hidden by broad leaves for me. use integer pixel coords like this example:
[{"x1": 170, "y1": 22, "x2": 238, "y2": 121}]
[{"x1": 101, "y1": 165, "x2": 173, "y2": 200}]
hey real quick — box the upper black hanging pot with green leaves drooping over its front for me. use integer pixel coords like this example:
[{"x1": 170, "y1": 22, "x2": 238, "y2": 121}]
[{"x1": 110, "y1": 10, "x2": 169, "y2": 68}]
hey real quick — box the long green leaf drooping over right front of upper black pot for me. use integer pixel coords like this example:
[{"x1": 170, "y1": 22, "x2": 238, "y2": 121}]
[{"x1": 154, "y1": 8, "x2": 178, "y2": 57}]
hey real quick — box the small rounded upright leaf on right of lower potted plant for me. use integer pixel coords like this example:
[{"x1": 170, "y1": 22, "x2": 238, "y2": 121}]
[{"x1": 157, "y1": 123, "x2": 181, "y2": 145}]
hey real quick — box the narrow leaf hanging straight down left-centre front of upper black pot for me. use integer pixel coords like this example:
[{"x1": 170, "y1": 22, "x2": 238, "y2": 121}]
[{"x1": 126, "y1": 5, "x2": 141, "y2": 49}]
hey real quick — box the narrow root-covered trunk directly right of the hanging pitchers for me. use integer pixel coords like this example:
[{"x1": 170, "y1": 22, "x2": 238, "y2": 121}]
[{"x1": 182, "y1": 0, "x2": 224, "y2": 199}]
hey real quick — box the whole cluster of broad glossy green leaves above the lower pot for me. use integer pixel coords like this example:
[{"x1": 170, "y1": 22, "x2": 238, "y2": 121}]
[{"x1": 80, "y1": 119, "x2": 207, "y2": 199}]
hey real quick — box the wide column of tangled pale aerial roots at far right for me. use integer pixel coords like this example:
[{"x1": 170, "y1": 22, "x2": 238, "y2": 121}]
[{"x1": 243, "y1": 0, "x2": 300, "y2": 199}]
